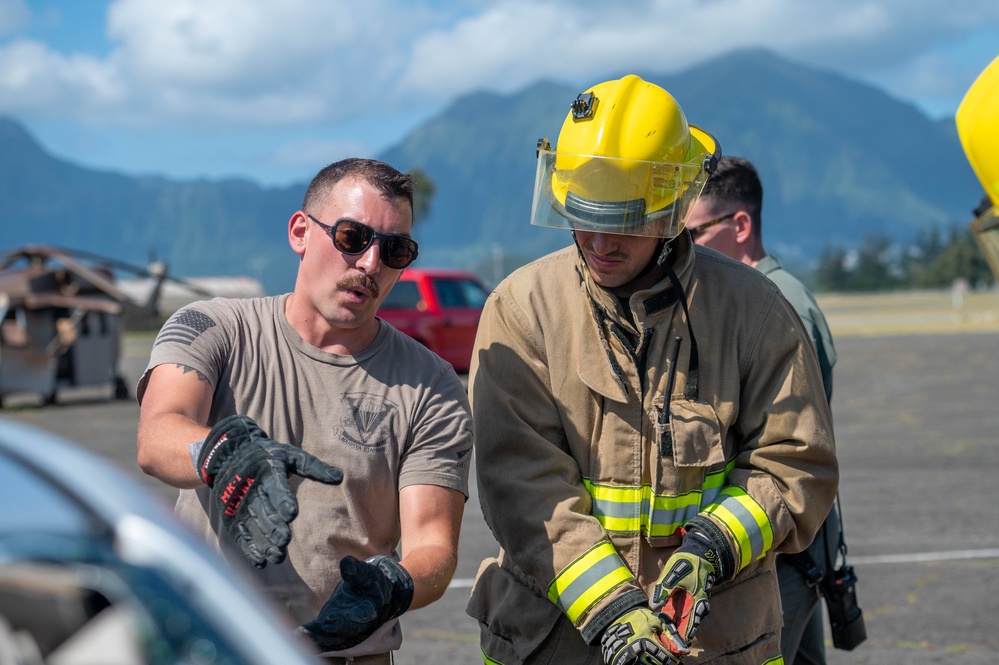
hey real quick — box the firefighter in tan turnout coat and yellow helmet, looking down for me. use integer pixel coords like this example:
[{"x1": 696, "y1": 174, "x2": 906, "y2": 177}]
[{"x1": 467, "y1": 76, "x2": 838, "y2": 665}]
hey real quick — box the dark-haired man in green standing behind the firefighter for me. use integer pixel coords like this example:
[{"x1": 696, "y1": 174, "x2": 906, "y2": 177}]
[{"x1": 687, "y1": 157, "x2": 841, "y2": 665}]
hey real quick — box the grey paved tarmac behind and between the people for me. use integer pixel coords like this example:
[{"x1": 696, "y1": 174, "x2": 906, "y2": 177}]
[{"x1": 0, "y1": 333, "x2": 999, "y2": 665}]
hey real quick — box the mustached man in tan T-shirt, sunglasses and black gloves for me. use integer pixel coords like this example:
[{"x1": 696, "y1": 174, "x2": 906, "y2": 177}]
[{"x1": 136, "y1": 159, "x2": 472, "y2": 664}]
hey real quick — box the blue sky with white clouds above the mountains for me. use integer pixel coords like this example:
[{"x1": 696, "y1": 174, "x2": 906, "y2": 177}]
[{"x1": 0, "y1": 0, "x2": 999, "y2": 185}]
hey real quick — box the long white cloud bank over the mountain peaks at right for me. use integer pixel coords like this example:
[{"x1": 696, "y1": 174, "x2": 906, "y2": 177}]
[{"x1": 400, "y1": 0, "x2": 999, "y2": 115}]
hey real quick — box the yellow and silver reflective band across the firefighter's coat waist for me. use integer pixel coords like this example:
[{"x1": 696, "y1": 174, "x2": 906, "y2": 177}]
[{"x1": 583, "y1": 460, "x2": 735, "y2": 537}]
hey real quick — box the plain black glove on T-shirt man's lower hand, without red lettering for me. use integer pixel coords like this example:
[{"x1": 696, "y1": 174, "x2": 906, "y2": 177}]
[{"x1": 298, "y1": 554, "x2": 413, "y2": 651}]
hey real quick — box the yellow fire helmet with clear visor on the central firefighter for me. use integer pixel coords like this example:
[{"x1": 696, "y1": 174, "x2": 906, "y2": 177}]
[{"x1": 531, "y1": 75, "x2": 721, "y2": 238}]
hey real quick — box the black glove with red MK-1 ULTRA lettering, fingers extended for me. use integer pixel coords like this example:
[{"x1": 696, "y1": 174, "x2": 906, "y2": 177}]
[{"x1": 198, "y1": 415, "x2": 343, "y2": 568}]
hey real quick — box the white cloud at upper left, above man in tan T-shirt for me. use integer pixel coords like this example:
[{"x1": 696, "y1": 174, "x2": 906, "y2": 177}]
[{"x1": 0, "y1": 0, "x2": 424, "y2": 127}]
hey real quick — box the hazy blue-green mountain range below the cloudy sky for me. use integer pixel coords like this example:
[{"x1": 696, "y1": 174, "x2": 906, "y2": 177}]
[{"x1": 0, "y1": 49, "x2": 983, "y2": 293}]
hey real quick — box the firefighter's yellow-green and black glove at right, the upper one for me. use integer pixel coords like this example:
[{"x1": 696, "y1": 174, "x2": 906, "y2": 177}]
[{"x1": 649, "y1": 530, "x2": 721, "y2": 645}]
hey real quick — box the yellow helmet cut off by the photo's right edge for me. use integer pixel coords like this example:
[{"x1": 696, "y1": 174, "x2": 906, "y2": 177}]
[{"x1": 955, "y1": 53, "x2": 999, "y2": 279}]
